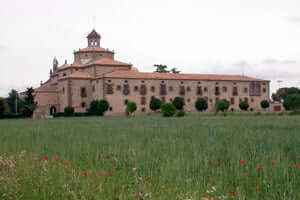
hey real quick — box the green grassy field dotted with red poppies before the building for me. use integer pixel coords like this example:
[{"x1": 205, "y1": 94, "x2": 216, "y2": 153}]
[{"x1": 0, "y1": 115, "x2": 300, "y2": 200}]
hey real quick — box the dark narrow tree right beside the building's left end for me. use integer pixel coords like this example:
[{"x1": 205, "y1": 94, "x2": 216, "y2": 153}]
[{"x1": 22, "y1": 87, "x2": 37, "y2": 117}]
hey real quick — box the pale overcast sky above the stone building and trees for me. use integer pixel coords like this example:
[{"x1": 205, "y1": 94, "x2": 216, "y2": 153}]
[{"x1": 0, "y1": 0, "x2": 300, "y2": 96}]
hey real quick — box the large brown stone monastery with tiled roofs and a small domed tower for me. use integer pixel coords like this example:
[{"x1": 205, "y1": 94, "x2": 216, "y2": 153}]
[{"x1": 35, "y1": 30, "x2": 270, "y2": 116}]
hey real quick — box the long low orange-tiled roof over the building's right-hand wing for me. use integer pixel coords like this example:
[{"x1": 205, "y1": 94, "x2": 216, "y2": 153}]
[{"x1": 102, "y1": 70, "x2": 266, "y2": 81}]
